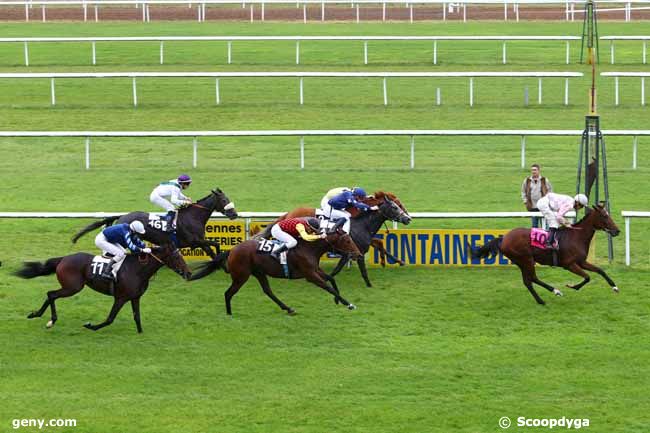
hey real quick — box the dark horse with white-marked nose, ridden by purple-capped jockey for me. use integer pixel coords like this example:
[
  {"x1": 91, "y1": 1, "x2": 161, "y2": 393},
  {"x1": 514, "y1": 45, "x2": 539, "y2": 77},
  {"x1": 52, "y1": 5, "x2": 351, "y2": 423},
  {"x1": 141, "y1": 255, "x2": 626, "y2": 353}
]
[{"x1": 72, "y1": 188, "x2": 237, "y2": 258}]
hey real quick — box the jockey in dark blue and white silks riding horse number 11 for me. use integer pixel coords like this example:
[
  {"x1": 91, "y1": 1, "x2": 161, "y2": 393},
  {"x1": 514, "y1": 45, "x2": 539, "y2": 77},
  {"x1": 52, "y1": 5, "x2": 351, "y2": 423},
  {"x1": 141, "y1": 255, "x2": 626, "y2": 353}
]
[{"x1": 95, "y1": 221, "x2": 151, "y2": 281}]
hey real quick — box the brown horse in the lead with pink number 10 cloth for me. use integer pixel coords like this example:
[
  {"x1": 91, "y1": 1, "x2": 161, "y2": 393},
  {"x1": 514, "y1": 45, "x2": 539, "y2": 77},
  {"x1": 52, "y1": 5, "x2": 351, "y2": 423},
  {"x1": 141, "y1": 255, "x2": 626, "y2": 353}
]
[{"x1": 471, "y1": 204, "x2": 620, "y2": 305}]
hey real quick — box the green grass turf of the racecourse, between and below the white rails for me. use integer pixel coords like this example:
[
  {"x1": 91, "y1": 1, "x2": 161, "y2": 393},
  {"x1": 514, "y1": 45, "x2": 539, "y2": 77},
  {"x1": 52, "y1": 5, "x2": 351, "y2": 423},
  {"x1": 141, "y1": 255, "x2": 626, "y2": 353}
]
[{"x1": 0, "y1": 18, "x2": 650, "y2": 433}]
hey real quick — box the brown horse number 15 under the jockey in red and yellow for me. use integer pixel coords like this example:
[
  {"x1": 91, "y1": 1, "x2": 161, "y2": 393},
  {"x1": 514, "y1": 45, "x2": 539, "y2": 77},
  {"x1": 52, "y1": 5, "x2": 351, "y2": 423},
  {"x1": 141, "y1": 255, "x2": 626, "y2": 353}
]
[{"x1": 191, "y1": 230, "x2": 361, "y2": 315}]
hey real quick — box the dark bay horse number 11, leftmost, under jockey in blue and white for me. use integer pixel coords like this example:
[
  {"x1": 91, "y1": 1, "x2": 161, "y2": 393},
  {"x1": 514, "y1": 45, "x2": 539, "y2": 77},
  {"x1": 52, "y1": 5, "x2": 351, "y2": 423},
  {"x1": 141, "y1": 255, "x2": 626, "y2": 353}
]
[{"x1": 16, "y1": 244, "x2": 191, "y2": 332}]
